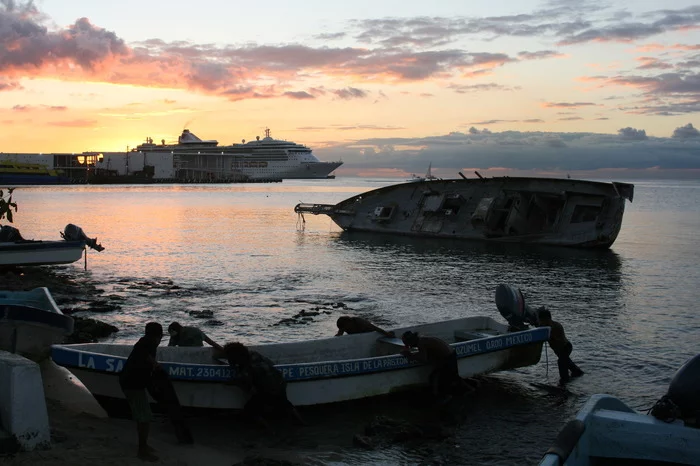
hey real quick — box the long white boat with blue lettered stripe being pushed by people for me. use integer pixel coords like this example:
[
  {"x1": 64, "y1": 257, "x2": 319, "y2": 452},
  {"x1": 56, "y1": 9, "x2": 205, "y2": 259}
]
[{"x1": 51, "y1": 317, "x2": 550, "y2": 409}]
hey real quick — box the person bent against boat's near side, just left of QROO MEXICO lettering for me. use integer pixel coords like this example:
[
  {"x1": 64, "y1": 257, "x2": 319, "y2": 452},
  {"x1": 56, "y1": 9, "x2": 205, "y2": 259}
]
[{"x1": 401, "y1": 331, "x2": 466, "y2": 397}]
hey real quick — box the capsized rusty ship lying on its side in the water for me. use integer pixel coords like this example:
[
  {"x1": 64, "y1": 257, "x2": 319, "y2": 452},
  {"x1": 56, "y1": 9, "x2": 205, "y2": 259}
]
[{"x1": 294, "y1": 173, "x2": 634, "y2": 248}]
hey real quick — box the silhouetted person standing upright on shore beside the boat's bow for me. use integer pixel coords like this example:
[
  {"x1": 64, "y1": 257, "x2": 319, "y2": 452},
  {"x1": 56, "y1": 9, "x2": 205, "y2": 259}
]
[{"x1": 119, "y1": 322, "x2": 163, "y2": 462}]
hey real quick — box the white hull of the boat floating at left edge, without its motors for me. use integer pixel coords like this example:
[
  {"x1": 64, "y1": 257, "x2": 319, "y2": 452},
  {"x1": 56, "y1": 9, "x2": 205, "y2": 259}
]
[{"x1": 0, "y1": 241, "x2": 85, "y2": 266}]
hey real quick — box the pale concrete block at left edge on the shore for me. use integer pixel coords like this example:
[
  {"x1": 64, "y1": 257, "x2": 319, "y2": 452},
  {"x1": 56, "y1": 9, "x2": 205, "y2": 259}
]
[{"x1": 0, "y1": 351, "x2": 51, "y2": 451}]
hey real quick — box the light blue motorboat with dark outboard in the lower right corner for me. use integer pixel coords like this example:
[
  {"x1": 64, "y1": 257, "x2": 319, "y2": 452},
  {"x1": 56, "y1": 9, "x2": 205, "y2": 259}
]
[{"x1": 540, "y1": 355, "x2": 700, "y2": 466}]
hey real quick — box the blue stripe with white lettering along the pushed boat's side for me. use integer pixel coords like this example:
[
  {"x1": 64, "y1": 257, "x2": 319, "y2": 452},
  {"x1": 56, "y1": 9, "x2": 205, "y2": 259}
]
[{"x1": 51, "y1": 327, "x2": 549, "y2": 382}]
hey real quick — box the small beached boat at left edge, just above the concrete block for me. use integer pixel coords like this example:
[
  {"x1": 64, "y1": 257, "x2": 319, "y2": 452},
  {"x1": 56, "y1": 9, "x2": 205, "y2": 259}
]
[{"x1": 0, "y1": 287, "x2": 73, "y2": 356}]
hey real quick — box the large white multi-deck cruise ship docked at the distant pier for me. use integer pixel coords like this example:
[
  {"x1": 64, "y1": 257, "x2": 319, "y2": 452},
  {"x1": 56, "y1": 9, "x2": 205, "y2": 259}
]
[{"x1": 121, "y1": 129, "x2": 343, "y2": 181}]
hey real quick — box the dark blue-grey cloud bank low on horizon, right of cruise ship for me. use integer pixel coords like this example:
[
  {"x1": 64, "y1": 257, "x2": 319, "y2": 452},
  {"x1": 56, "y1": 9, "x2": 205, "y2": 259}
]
[{"x1": 315, "y1": 123, "x2": 700, "y2": 178}]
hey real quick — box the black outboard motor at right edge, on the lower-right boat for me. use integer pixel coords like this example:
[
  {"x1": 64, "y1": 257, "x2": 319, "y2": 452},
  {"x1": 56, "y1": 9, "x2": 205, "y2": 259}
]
[{"x1": 651, "y1": 354, "x2": 700, "y2": 423}]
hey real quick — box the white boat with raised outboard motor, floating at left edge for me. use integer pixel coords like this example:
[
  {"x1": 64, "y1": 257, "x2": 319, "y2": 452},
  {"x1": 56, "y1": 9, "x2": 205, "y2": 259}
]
[{"x1": 0, "y1": 224, "x2": 104, "y2": 267}]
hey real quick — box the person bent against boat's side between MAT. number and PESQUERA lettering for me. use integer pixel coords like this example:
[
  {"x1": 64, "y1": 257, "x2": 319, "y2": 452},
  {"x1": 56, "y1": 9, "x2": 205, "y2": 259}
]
[{"x1": 224, "y1": 343, "x2": 305, "y2": 431}]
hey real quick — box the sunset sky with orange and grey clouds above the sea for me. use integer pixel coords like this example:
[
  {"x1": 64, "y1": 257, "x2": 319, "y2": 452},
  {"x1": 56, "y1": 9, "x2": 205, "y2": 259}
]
[{"x1": 0, "y1": 0, "x2": 700, "y2": 179}]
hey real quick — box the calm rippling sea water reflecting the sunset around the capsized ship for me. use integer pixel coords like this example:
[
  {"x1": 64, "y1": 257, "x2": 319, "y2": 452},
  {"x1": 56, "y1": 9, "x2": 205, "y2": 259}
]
[{"x1": 5, "y1": 179, "x2": 700, "y2": 464}]
